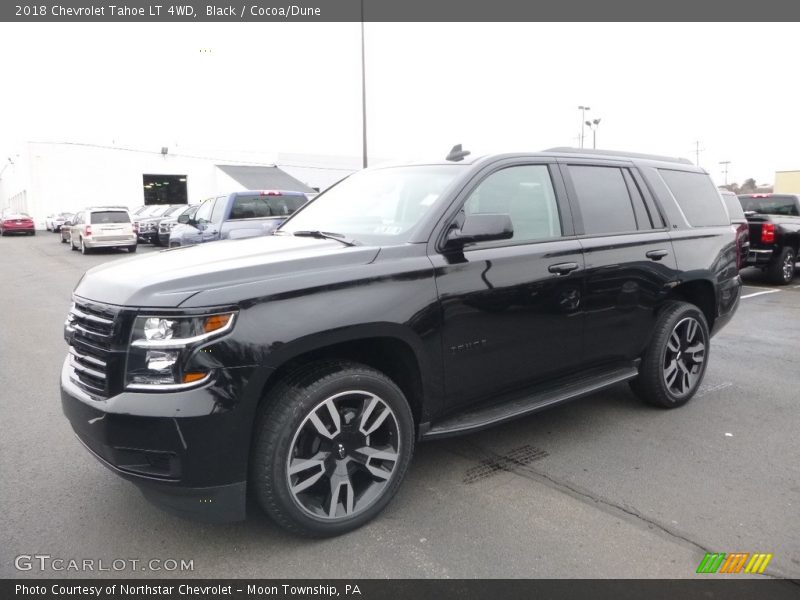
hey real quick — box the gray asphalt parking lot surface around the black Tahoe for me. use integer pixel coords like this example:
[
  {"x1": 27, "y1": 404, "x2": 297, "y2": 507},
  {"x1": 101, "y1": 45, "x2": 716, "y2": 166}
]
[{"x1": 0, "y1": 232, "x2": 800, "y2": 578}]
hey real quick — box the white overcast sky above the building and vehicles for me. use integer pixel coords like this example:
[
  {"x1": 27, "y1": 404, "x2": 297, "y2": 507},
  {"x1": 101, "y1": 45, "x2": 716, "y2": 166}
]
[{"x1": 0, "y1": 23, "x2": 800, "y2": 183}]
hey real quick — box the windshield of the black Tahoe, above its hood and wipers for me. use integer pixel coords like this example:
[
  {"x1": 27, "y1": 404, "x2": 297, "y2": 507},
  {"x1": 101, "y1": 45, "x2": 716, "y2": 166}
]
[{"x1": 279, "y1": 165, "x2": 463, "y2": 245}]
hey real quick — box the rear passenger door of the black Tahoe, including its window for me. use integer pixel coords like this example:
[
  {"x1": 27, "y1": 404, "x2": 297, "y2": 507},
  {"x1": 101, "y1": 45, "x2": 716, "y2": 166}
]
[{"x1": 561, "y1": 160, "x2": 677, "y2": 366}]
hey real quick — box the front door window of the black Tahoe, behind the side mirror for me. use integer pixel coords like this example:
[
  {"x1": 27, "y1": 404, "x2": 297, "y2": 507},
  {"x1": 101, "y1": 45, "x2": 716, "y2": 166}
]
[{"x1": 464, "y1": 165, "x2": 561, "y2": 242}]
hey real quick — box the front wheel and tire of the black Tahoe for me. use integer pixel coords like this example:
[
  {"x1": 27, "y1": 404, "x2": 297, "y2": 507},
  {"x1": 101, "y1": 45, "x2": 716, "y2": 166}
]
[{"x1": 250, "y1": 361, "x2": 414, "y2": 537}]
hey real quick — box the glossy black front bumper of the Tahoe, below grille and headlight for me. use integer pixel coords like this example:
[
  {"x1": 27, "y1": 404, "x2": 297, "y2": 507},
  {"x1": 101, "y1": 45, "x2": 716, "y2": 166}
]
[{"x1": 61, "y1": 360, "x2": 253, "y2": 522}]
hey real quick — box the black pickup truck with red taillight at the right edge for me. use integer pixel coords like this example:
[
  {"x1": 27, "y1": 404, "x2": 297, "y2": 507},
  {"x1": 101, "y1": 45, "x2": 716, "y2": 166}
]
[{"x1": 739, "y1": 194, "x2": 800, "y2": 285}]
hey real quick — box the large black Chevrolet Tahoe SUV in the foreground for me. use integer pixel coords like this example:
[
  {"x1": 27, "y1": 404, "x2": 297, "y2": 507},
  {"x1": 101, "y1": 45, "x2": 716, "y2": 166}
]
[{"x1": 61, "y1": 149, "x2": 741, "y2": 536}]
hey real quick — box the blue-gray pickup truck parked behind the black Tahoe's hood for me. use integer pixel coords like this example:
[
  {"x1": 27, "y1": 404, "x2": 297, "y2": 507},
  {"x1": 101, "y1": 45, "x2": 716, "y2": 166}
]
[{"x1": 169, "y1": 190, "x2": 308, "y2": 248}]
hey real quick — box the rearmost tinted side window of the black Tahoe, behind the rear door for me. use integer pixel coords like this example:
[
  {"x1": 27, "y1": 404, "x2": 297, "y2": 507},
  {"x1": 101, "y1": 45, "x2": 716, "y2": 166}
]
[{"x1": 658, "y1": 169, "x2": 730, "y2": 227}]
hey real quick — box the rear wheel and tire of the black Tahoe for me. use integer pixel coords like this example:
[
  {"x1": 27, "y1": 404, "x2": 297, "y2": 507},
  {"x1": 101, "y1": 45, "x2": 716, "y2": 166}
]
[{"x1": 631, "y1": 302, "x2": 710, "y2": 408}]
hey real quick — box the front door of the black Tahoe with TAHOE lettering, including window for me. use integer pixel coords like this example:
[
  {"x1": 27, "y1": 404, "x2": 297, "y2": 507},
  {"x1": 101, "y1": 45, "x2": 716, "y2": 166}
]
[{"x1": 431, "y1": 159, "x2": 583, "y2": 406}]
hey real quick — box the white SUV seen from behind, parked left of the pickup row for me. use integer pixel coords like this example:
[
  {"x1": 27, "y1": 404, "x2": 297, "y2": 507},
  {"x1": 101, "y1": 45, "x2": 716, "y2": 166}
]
[{"x1": 69, "y1": 206, "x2": 137, "y2": 254}]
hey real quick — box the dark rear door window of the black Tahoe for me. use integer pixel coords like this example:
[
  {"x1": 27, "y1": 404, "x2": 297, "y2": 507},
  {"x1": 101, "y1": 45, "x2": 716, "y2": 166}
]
[{"x1": 569, "y1": 165, "x2": 637, "y2": 235}]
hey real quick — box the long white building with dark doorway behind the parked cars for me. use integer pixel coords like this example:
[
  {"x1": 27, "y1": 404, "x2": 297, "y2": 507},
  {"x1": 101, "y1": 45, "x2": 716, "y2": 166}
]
[{"x1": 0, "y1": 142, "x2": 361, "y2": 228}]
